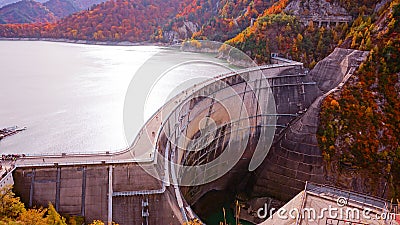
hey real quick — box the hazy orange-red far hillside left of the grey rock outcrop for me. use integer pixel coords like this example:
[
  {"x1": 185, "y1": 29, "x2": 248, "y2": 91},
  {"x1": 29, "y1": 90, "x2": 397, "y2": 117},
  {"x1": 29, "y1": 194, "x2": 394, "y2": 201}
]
[{"x1": 0, "y1": 0, "x2": 181, "y2": 42}]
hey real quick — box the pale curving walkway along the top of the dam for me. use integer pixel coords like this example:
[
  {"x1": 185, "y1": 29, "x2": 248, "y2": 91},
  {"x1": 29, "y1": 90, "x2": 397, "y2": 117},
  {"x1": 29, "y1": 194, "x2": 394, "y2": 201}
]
[{"x1": 7, "y1": 58, "x2": 304, "y2": 167}]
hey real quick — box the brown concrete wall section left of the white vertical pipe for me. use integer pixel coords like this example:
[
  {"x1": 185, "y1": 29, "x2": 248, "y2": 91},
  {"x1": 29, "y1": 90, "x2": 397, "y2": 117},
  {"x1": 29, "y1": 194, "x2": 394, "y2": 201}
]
[{"x1": 14, "y1": 166, "x2": 108, "y2": 221}]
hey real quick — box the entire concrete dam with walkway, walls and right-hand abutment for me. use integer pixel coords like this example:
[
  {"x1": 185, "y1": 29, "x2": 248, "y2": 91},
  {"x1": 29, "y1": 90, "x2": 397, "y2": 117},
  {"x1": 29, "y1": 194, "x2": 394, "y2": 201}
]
[{"x1": 2, "y1": 48, "x2": 368, "y2": 225}]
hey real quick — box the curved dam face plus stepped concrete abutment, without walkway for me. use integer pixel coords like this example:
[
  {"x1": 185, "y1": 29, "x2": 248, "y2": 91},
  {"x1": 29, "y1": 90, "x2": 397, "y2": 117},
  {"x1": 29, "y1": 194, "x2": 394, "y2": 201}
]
[{"x1": 157, "y1": 49, "x2": 366, "y2": 223}]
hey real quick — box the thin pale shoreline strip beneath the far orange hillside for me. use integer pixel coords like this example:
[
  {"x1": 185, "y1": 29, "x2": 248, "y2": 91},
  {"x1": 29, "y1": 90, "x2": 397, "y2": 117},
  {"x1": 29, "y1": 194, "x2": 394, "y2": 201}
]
[{"x1": 0, "y1": 37, "x2": 176, "y2": 47}]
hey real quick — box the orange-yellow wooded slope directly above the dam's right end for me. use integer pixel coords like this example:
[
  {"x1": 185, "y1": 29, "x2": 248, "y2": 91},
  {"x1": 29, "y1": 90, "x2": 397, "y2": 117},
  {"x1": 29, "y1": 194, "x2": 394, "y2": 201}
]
[{"x1": 227, "y1": 0, "x2": 347, "y2": 67}]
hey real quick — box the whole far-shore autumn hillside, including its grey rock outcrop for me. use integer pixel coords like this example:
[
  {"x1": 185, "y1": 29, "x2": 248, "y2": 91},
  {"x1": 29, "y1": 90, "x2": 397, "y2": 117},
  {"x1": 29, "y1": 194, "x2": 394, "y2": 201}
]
[{"x1": 0, "y1": 0, "x2": 278, "y2": 42}]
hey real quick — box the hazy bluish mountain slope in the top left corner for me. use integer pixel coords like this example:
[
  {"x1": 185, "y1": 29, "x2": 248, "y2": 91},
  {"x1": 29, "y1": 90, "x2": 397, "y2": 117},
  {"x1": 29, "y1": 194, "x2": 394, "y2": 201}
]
[{"x1": 0, "y1": 0, "x2": 56, "y2": 23}]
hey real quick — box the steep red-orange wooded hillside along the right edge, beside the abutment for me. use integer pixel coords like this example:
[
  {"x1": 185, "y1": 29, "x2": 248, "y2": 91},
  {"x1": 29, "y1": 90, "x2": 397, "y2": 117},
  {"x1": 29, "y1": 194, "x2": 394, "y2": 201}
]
[{"x1": 318, "y1": 0, "x2": 400, "y2": 198}]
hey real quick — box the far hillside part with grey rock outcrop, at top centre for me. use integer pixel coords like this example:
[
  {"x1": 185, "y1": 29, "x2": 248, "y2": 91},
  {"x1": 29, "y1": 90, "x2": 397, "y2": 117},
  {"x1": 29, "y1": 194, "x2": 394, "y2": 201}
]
[{"x1": 164, "y1": 0, "x2": 274, "y2": 42}]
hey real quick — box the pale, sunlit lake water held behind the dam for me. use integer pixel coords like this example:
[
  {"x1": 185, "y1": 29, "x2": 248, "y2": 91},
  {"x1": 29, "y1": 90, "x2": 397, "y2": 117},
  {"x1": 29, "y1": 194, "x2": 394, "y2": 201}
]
[{"x1": 0, "y1": 41, "x2": 234, "y2": 154}]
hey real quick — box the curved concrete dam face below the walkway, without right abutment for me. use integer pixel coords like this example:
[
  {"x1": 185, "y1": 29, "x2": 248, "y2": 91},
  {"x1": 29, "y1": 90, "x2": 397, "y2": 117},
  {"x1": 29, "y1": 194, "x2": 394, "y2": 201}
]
[{"x1": 153, "y1": 66, "x2": 313, "y2": 224}]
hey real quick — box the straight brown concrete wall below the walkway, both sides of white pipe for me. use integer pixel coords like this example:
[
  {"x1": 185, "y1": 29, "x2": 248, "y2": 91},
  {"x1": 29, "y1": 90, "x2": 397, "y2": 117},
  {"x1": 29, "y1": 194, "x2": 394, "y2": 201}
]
[{"x1": 13, "y1": 163, "x2": 179, "y2": 224}]
